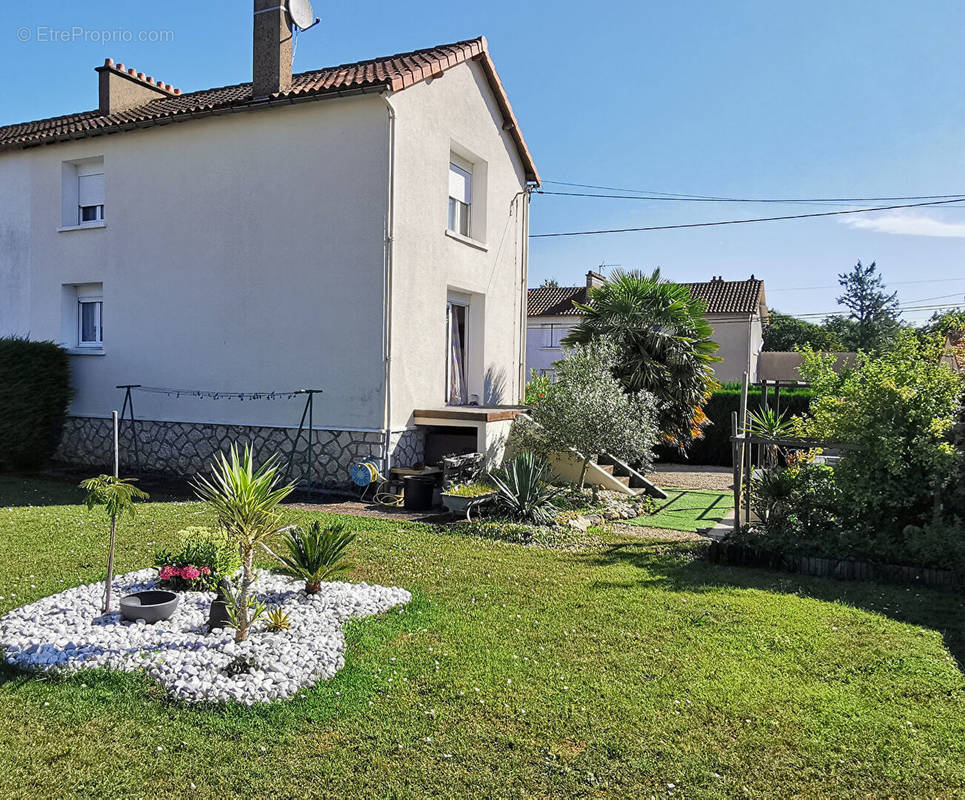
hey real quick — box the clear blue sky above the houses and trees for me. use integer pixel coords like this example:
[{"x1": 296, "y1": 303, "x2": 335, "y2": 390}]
[{"x1": 0, "y1": 0, "x2": 965, "y2": 320}]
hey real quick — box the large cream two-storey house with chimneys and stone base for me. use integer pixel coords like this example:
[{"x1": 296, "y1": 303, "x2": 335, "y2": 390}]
[{"x1": 0, "y1": 10, "x2": 539, "y2": 484}]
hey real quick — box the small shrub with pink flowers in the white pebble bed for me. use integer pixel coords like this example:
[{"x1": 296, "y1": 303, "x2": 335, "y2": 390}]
[{"x1": 154, "y1": 527, "x2": 241, "y2": 591}]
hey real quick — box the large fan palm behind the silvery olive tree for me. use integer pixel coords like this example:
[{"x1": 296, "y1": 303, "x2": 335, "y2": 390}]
[{"x1": 563, "y1": 269, "x2": 720, "y2": 450}]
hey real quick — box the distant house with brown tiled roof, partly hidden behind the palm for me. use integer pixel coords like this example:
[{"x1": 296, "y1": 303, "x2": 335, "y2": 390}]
[{"x1": 526, "y1": 271, "x2": 768, "y2": 383}]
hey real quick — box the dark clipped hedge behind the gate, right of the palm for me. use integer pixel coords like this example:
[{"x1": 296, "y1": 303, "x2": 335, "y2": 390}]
[{"x1": 657, "y1": 383, "x2": 811, "y2": 467}]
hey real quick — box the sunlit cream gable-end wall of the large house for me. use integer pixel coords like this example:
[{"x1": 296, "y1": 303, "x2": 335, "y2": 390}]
[{"x1": 390, "y1": 62, "x2": 527, "y2": 427}]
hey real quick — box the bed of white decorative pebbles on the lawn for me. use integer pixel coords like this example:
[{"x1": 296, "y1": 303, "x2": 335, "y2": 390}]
[{"x1": 0, "y1": 569, "x2": 411, "y2": 705}]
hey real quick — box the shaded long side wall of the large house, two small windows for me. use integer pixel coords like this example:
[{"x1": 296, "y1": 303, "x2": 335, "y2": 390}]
[{"x1": 0, "y1": 96, "x2": 388, "y2": 429}]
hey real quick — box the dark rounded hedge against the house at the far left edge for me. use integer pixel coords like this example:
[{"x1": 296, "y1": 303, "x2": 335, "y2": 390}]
[{"x1": 0, "y1": 337, "x2": 73, "y2": 469}]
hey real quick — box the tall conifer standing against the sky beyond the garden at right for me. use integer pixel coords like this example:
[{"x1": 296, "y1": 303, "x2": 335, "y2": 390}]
[{"x1": 826, "y1": 261, "x2": 900, "y2": 353}]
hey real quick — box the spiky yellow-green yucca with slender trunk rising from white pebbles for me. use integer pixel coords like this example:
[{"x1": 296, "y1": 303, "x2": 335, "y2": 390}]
[{"x1": 192, "y1": 445, "x2": 295, "y2": 642}]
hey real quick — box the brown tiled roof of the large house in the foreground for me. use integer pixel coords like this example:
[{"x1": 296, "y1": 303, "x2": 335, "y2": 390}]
[{"x1": 0, "y1": 36, "x2": 539, "y2": 184}]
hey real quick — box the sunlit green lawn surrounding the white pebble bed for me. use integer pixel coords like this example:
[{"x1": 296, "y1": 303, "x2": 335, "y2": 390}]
[{"x1": 0, "y1": 477, "x2": 965, "y2": 799}]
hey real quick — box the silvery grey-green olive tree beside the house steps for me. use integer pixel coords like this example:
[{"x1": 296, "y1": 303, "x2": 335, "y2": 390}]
[{"x1": 520, "y1": 339, "x2": 659, "y2": 488}]
